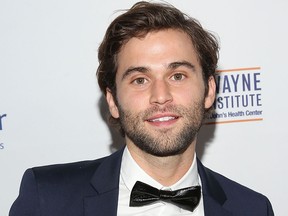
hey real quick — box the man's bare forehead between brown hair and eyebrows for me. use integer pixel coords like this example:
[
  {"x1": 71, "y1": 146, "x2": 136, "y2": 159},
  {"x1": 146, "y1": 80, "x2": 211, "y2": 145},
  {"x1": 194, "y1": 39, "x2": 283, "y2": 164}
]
[{"x1": 117, "y1": 29, "x2": 199, "y2": 72}]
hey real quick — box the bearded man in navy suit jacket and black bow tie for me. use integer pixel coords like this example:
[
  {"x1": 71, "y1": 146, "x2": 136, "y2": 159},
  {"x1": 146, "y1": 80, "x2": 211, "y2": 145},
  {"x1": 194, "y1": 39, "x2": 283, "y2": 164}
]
[{"x1": 10, "y1": 2, "x2": 274, "y2": 216}]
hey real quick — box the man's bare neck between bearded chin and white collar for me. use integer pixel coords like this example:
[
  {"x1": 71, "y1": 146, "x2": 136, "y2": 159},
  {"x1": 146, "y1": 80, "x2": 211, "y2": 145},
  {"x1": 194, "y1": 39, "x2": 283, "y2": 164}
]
[{"x1": 127, "y1": 141, "x2": 196, "y2": 186}]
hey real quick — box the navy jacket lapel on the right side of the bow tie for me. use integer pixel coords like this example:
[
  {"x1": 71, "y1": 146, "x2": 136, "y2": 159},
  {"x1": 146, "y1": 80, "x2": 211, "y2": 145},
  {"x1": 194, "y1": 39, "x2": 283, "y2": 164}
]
[{"x1": 197, "y1": 159, "x2": 232, "y2": 216}]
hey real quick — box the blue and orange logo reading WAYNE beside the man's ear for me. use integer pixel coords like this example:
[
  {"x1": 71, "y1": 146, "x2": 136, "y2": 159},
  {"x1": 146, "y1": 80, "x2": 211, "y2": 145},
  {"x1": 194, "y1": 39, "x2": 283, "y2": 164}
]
[{"x1": 206, "y1": 67, "x2": 263, "y2": 124}]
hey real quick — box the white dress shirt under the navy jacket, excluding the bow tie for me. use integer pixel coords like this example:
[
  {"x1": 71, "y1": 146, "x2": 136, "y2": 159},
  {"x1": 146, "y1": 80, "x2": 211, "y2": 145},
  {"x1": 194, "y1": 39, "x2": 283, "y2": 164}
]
[{"x1": 117, "y1": 147, "x2": 204, "y2": 216}]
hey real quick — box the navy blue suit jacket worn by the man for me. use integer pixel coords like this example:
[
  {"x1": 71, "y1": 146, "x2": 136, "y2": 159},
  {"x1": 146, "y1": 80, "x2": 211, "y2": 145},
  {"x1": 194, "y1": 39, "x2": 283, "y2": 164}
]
[{"x1": 9, "y1": 150, "x2": 274, "y2": 216}]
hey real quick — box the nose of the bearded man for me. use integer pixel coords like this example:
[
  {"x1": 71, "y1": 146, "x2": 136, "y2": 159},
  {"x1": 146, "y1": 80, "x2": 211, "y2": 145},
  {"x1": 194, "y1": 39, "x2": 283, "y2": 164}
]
[{"x1": 150, "y1": 80, "x2": 173, "y2": 105}]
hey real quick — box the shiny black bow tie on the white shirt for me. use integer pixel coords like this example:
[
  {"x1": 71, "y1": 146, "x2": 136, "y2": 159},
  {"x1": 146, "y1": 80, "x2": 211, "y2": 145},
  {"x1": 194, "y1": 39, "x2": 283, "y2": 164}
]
[{"x1": 130, "y1": 181, "x2": 201, "y2": 211}]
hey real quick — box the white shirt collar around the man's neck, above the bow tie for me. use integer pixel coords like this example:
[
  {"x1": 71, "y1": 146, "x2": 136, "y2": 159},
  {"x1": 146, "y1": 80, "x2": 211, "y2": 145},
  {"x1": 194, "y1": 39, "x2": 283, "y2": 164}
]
[{"x1": 120, "y1": 147, "x2": 199, "y2": 191}]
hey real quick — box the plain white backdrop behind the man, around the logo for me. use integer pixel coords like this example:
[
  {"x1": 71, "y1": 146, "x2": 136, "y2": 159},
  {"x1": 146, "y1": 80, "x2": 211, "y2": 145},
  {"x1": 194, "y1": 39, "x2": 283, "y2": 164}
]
[{"x1": 0, "y1": 0, "x2": 288, "y2": 216}]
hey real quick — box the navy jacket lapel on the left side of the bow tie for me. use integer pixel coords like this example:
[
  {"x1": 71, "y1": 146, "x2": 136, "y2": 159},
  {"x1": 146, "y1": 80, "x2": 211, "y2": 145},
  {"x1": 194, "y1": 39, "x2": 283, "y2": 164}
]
[{"x1": 84, "y1": 149, "x2": 123, "y2": 216}]
